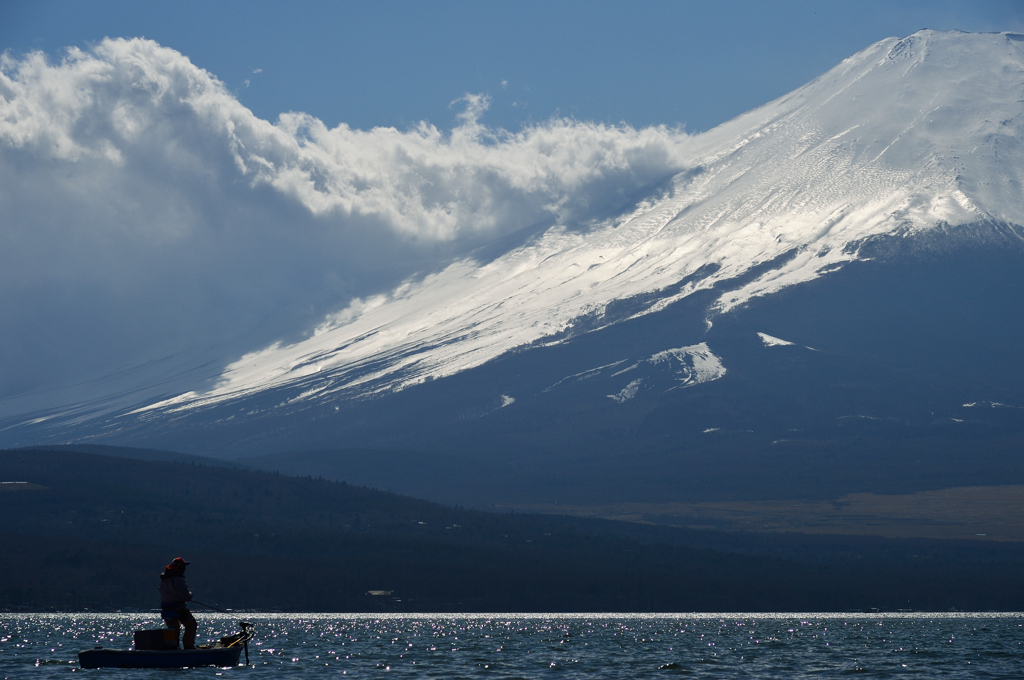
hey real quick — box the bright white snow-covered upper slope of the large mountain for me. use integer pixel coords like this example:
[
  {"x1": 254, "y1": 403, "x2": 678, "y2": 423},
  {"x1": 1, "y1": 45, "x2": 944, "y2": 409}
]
[{"x1": 128, "y1": 31, "x2": 1024, "y2": 415}]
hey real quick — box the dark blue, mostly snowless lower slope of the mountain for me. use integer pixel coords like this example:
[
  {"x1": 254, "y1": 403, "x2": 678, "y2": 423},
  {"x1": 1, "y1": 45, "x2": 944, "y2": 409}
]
[{"x1": 81, "y1": 236, "x2": 1024, "y2": 505}]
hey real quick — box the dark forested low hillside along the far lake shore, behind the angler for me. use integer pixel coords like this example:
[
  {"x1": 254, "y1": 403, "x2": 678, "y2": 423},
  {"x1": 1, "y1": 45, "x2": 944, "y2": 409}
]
[{"x1": 0, "y1": 450, "x2": 1024, "y2": 611}]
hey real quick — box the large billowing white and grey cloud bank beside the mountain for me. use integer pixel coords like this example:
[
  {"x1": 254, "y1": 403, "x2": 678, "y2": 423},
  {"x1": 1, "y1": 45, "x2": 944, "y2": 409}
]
[{"x1": 0, "y1": 39, "x2": 689, "y2": 415}]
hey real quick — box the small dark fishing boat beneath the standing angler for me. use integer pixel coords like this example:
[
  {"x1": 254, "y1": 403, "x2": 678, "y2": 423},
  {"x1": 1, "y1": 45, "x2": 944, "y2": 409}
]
[{"x1": 78, "y1": 621, "x2": 253, "y2": 668}]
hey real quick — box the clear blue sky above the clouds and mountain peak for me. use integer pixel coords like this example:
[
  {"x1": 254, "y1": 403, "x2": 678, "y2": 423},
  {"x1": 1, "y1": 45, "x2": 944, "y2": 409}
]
[{"x1": 0, "y1": 0, "x2": 1024, "y2": 132}]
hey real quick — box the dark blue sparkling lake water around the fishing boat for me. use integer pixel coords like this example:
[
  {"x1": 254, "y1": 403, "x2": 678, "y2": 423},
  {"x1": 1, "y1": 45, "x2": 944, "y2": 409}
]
[{"x1": 0, "y1": 613, "x2": 1024, "y2": 680}]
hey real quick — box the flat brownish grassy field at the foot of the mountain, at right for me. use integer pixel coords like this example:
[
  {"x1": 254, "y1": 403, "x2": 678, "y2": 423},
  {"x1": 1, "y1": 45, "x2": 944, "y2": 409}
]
[{"x1": 514, "y1": 485, "x2": 1024, "y2": 542}]
